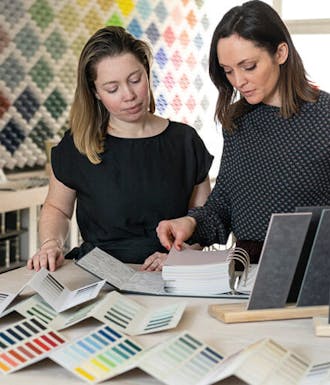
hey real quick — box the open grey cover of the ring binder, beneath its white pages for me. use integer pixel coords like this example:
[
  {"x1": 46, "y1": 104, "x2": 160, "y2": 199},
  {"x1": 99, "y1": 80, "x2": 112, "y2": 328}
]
[{"x1": 75, "y1": 247, "x2": 252, "y2": 298}]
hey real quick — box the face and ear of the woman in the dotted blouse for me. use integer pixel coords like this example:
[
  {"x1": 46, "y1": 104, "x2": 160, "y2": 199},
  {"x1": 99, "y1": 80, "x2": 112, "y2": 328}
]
[{"x1": 217, "y1": 34, "x2": 287, "y2": 107}]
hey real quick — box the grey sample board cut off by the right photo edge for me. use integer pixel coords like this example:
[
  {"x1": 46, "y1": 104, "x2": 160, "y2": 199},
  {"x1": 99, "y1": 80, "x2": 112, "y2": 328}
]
[{"x1": 297, "y1": 210, "x2": 330, "y2": 306}]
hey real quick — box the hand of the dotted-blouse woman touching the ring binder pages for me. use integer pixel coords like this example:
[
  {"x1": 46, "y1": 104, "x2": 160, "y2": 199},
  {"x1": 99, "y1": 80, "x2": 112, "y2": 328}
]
[{"x1": 156, "y1": 216, "x2": 197, "y2": 250}]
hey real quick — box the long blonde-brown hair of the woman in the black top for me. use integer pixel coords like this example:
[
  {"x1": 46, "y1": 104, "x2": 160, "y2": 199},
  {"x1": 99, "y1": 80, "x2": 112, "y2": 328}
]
[{"x1": 69, "y1": 26, "x2": 155, "y2": 164}]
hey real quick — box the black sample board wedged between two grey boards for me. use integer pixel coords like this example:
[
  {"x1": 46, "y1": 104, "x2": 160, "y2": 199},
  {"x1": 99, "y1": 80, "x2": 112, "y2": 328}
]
[{"x1": 287, "y1": 206, "x2": 330, "y2": 302}]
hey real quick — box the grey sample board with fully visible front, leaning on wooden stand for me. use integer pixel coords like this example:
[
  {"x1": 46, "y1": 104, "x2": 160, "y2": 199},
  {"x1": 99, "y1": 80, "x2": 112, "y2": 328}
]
[{"x1": 247, "y1": 213, "x2": 312, "y2": 310}]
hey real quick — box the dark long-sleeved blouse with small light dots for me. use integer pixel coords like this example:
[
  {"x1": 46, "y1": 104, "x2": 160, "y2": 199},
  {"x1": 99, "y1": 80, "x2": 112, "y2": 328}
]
[{"x1": 190, "y1": 92, "x2": 330, "y2": 245}]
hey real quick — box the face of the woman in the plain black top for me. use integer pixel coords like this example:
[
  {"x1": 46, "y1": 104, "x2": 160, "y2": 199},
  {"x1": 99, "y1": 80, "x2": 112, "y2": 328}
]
[{"x1": 94, "y1": 53, "x2": 150, "y2": 122}]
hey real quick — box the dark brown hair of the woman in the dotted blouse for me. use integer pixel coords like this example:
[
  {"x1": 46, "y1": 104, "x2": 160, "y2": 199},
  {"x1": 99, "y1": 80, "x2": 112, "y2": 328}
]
[{"x1": 209, "y1": 0, "x2": 319, "y2": 131}]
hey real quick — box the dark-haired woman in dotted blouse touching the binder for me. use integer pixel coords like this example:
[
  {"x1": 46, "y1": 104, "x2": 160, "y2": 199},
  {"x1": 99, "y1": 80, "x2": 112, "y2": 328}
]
[{"x1": 157, "y1": 1, "x2": 330, "y2": 262}]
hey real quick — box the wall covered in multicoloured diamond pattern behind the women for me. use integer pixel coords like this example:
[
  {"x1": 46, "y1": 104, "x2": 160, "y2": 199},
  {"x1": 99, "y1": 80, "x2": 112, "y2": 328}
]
[{"x1": 0, "y1": 0, "x2": 213, "y2": 171}]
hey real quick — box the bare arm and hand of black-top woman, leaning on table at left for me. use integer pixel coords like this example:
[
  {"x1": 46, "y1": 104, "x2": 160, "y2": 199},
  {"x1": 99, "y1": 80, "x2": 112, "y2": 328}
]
[{"x1": 27, "y1": 172, "x2": 76, "y2": 271}]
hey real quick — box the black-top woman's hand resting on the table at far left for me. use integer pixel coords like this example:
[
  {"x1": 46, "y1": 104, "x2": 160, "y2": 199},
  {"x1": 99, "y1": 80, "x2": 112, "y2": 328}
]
[{"x1": 27, "y1": 240, "x2": 64, "y2": 271}]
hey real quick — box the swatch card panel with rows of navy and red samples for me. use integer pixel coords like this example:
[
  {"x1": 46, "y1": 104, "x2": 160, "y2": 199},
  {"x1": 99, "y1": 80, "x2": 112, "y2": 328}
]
[{"x1": 0, "y1": 318, "x2": 66, "y2": 374}]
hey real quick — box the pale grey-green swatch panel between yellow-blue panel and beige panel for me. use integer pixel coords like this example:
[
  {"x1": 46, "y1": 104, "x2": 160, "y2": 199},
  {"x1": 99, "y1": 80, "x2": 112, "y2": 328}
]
[{"x1": 139, "y1": 332, "x2": 223, "y2": 385}]
